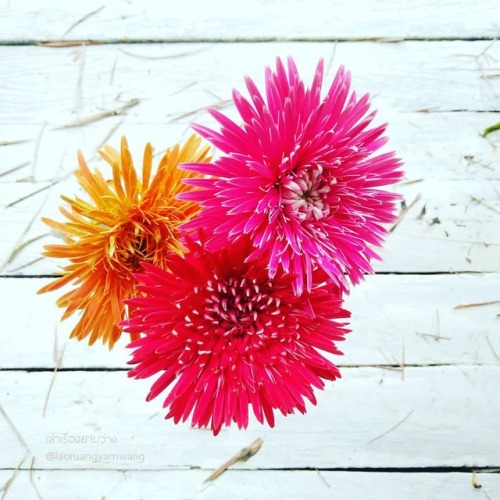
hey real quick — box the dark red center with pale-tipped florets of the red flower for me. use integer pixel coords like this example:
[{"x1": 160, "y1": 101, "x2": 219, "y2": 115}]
[{"x1": 199, "y1": 277, "x2": 283, "y2": 338}]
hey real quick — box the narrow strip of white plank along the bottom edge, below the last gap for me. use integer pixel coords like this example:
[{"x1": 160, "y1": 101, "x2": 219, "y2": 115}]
[{"x1": 0, "y1": 470, "x2": 500, "y2": 500}]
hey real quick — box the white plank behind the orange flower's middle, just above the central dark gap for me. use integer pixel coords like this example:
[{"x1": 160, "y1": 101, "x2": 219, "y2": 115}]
[{"x1": 0, "y1": 178, "x2": 500, "y2": 275}]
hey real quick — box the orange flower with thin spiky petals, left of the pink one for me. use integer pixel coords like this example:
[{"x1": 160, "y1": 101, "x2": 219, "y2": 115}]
[{"x1": 38, "y1": 135, "x2": 210, "y2": 349}]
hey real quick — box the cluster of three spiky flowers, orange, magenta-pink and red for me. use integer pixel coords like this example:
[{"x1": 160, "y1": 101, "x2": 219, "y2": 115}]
[{"x1": 40, "y1": 58, "x2": 402, "y2": 434}]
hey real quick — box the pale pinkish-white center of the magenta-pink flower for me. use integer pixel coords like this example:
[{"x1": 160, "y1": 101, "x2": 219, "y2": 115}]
[{"x1": 281, "y1": 164, "x2": 337, "y2": 220}]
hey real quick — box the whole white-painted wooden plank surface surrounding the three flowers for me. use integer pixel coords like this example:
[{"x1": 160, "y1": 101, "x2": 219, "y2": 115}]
[{"x1": 0, "y1": 0, "x2": 500, "y2": 500}]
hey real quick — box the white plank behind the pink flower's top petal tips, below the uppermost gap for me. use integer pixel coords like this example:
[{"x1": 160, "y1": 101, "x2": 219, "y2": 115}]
[{"x1": 0, "y1": 41, "x2": 500, "y2": 129}]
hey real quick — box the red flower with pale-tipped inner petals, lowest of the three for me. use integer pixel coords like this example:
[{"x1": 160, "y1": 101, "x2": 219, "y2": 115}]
[{"x1": 123, "y1": 239, "x2": 349, "y2": 434}]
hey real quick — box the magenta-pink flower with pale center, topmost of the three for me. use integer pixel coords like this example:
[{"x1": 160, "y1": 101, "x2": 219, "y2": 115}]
[{"x1": 181, "y1": 58, "x2": 402, "y2": 293}]
